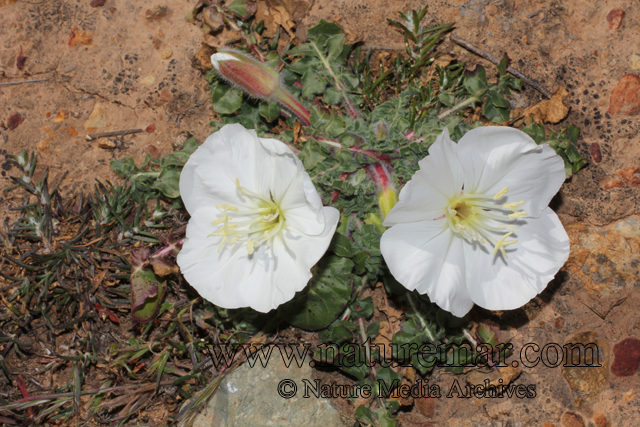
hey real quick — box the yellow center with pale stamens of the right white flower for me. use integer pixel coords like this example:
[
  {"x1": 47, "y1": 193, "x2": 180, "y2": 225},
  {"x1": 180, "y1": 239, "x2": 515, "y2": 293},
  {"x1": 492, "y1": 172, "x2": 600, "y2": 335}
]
[{"x1": 446, "y1": 187, "x2": 529, "y2": 258}]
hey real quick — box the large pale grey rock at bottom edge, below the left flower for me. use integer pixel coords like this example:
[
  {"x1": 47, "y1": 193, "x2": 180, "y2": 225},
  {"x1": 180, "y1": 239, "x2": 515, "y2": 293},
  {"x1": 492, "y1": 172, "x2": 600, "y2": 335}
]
[{"x1": 193, "y1": 348, "x2": 344, "y2": 427}]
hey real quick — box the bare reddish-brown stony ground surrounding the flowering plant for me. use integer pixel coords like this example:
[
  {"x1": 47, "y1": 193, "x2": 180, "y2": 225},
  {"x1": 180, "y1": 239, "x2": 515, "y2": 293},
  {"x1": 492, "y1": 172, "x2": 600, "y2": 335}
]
[{"x1": 0, "y1": 0, "x2": 640, "y2": 427}]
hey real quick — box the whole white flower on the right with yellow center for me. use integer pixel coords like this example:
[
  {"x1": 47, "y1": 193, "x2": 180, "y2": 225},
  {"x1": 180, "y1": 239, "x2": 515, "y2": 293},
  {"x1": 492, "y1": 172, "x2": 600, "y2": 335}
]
[{"x1": 380, "y1": 126, "x2": 569, "y2": 317}]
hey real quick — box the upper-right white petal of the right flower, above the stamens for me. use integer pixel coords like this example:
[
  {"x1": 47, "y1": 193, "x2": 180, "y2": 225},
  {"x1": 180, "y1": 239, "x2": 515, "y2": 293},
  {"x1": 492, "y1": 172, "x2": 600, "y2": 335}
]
[{"x1": 456, "y1": 126, "x2": 565, "y2": 217}]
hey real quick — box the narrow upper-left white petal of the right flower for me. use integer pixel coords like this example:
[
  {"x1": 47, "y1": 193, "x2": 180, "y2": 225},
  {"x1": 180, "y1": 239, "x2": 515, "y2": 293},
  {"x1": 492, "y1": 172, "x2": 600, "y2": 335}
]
[{"x1": 384, "y1": 128, "x2": 464, "y2": 227}]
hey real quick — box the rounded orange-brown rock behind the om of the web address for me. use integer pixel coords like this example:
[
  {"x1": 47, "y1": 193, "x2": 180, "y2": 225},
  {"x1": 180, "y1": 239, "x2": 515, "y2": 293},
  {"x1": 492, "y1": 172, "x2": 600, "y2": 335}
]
[{"x1": 560, "y1": 332, "x2": 609, "y2": 404}]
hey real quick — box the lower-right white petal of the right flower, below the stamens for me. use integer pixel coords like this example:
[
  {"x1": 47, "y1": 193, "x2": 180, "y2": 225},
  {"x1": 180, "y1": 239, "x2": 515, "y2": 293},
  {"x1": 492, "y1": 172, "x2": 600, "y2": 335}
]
[{"x1": 464, "y1": 208, "x2": 569, "y2": 310}]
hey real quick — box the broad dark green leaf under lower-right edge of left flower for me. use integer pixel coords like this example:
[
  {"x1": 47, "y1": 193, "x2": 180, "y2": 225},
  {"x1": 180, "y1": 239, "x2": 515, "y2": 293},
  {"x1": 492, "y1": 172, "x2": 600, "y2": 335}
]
[{"x1": 278, "y1": 255, "x2": 353, "y2": 331}]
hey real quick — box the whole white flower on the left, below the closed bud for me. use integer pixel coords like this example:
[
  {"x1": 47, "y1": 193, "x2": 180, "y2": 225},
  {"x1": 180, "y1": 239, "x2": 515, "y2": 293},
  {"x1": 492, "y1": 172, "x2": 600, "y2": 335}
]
[{"x1": 178, "y1": 124, "x2": 339, "y2": 312}]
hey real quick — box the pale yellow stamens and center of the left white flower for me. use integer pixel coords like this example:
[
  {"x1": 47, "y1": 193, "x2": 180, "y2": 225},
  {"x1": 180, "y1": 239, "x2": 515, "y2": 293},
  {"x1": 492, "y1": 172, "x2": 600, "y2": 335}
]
[{"x1": 207, "y1": 178, "x2": 284, "y2": 255}]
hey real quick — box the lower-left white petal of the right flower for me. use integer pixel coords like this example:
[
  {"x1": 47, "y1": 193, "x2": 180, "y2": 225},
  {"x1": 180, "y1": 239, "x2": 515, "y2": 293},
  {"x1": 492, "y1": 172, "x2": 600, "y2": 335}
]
[{"x1": 380, "y1": 219, "x2": 473, "y2": 317}]
